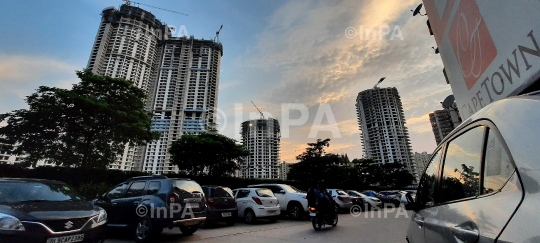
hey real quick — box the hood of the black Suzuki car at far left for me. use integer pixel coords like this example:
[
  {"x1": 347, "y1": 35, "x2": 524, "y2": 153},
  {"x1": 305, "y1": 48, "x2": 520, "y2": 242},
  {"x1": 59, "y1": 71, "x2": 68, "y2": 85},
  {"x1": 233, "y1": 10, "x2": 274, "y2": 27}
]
[{"x1": 0, "y1": 201, "x2": 100, "y2": 221}]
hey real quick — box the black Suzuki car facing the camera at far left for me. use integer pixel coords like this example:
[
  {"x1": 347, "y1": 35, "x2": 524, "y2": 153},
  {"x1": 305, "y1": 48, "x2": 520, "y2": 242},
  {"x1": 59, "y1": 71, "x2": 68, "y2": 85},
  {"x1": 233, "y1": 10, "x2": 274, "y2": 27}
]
[{"x1": 0, "y1": 178, "x2": 107, "y2": 243}]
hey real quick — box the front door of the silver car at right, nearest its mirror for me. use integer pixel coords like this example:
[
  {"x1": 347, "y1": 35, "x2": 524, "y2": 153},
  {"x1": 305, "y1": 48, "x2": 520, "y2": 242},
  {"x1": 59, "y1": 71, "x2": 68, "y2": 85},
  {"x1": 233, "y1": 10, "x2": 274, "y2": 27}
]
[{"x1": 407, "y1": 150, "x2": 441, "y2": 243}]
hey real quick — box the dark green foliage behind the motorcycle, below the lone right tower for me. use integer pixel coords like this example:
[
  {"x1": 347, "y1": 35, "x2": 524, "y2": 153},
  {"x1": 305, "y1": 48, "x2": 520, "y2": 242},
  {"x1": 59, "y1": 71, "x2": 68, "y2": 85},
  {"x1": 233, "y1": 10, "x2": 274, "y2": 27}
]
[{"x1": 288, "y1": 139, "x2": 414, "y2": 189}]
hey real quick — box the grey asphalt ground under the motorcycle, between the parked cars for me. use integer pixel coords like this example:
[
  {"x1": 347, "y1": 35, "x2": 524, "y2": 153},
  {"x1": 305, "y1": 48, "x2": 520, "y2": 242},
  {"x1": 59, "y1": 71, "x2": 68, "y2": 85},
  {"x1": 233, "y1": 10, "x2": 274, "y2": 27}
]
[{"x1": 106, "y1": 209, "x2": 411, "y2": 243}]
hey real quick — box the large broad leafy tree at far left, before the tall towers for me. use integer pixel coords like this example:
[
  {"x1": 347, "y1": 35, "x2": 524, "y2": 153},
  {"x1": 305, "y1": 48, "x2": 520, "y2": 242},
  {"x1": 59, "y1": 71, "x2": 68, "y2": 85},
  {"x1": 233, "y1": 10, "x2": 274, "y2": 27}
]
[{"x1": 0, "y1": 70, "x2": 158, "y2": 168}]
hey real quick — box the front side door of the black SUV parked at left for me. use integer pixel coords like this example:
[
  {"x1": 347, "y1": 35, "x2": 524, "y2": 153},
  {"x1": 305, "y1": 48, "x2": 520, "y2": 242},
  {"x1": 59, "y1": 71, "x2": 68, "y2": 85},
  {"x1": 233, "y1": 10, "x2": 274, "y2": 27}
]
[{"x1": 96, "y1": 183, "x2": 128, "y2": 226}]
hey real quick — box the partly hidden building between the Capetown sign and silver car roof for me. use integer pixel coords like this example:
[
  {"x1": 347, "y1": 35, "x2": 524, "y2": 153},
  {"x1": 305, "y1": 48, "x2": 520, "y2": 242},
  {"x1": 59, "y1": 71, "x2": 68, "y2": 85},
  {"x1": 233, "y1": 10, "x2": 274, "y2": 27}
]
[{"x1": 429, "y1": 105, "x2": 461, "y2": 145}]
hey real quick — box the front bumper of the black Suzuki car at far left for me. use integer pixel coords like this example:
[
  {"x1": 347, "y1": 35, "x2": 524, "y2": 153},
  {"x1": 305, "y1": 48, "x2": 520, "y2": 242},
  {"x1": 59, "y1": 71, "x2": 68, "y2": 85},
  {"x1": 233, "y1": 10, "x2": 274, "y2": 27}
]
[{"x1": 0, "y1": 222, "x2": 107, "y2": 243}]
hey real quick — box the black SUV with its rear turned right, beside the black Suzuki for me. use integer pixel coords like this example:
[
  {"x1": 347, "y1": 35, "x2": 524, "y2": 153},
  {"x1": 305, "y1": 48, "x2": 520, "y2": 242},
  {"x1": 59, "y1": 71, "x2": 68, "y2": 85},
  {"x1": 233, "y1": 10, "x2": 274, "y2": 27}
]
[{"x1": 94, "y1": 175, "x2": 206, "y2": 242}]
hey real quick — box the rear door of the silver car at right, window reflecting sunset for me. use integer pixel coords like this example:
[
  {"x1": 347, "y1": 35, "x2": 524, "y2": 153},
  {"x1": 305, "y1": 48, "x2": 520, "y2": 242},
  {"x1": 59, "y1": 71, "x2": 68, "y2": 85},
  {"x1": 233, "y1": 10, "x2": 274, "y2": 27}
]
[{"x1": 425, "y1": 122, "x2": 522, "y2": 243}]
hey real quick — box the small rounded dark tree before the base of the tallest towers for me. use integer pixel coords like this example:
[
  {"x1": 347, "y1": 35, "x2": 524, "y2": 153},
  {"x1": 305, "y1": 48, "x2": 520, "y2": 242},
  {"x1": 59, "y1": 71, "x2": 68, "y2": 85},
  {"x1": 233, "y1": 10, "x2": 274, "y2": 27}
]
[{"x1": 169, "y1": 132, "x2": 250, "y2": 176}]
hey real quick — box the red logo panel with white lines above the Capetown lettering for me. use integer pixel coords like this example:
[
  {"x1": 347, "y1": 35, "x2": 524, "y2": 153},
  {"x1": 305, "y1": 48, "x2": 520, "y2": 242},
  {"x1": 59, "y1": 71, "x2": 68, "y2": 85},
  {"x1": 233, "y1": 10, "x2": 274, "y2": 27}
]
[{"x1": 448, "y1": 0, "x2": 497, "y2": 90}]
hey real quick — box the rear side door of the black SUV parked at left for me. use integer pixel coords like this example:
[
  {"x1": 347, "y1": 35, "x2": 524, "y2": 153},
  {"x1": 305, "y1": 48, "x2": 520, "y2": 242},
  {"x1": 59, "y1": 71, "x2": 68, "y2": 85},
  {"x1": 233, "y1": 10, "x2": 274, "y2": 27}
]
[{"x1": 116, "y1": 181, "x2": 146, "y2": 225}]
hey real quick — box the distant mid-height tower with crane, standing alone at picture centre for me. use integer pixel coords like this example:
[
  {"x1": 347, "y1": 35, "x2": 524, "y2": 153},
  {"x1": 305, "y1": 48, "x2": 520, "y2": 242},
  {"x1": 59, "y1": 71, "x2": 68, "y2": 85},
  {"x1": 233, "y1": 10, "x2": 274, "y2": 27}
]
[{"x1": 241, "y1": 118, "x2": 281, "y2": 179}]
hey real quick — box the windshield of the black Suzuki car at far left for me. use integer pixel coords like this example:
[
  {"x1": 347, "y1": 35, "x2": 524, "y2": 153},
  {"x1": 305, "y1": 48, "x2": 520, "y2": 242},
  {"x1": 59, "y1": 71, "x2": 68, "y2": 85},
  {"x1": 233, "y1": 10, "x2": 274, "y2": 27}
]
[{"x1": 0, "y1": 181, "x2": 84, "y2": 204}]
